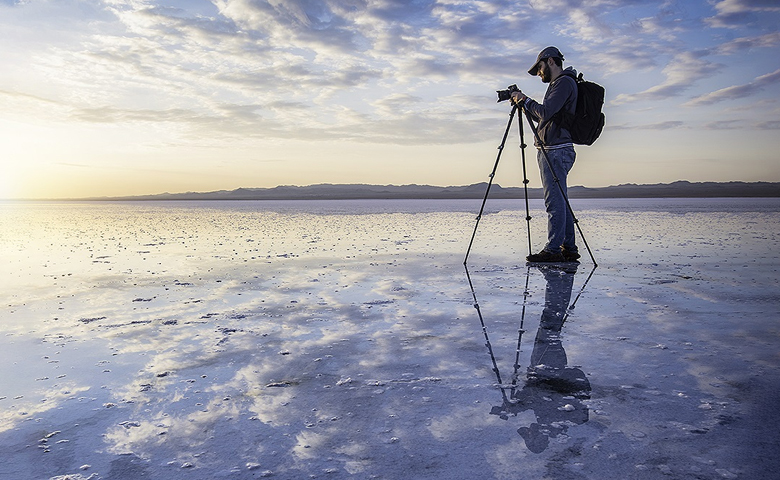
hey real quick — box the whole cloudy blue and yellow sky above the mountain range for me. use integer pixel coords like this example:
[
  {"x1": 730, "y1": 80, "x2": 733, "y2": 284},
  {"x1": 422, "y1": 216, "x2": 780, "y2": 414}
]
[{"x1": 0, "y1": 0, "x2": 780, "y2": 199}]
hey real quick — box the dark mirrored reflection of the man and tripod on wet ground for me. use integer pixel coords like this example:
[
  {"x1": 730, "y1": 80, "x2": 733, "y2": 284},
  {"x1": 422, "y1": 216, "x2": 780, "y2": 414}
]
[{"x1": 466, "y1": 264, "x2": 595, "y2": 453}]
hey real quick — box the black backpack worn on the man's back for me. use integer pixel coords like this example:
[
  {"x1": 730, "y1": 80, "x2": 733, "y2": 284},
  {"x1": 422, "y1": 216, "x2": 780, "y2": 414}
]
[{"x1": 555, "y1": 73, "x2": 604, "y2": 145}]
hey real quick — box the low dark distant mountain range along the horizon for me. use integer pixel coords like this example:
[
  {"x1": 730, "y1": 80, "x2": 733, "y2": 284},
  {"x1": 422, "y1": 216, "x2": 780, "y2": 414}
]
[{"x1": 86, "y1": 181, "x2": 780, "y2": 200}]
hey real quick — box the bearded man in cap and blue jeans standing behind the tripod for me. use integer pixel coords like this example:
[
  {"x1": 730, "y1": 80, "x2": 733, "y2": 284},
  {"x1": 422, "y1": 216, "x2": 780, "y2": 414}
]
[{"x1": 512, "y1": 47, "x2": 580, "y2": 263}]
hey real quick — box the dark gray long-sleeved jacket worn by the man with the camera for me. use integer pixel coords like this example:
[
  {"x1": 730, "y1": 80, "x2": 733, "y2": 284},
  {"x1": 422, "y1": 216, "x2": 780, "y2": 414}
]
[{"x1": 525, "y1": 67, "x2": 577, "y2": 147}]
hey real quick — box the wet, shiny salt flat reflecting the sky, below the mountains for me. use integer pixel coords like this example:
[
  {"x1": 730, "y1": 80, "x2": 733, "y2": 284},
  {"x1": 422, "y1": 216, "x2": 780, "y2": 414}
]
[{"x1": 0, "y1": 199, "x2": 780, "y2": 480}]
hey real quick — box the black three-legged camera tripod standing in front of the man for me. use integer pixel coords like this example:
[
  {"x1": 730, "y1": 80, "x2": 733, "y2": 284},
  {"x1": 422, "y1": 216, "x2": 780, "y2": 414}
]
[{"x1": 463, "y1": 104, "x2": 597, "y2": 266}]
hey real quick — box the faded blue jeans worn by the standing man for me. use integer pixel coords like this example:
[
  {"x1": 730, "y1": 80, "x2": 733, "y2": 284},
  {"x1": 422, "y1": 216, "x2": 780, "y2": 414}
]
[{"x1": 536, "y1": 147, "x2": 577, "y2": 253}]
